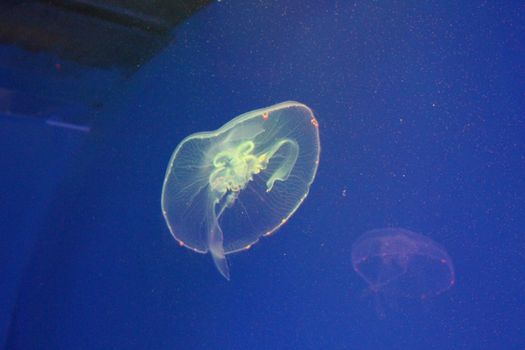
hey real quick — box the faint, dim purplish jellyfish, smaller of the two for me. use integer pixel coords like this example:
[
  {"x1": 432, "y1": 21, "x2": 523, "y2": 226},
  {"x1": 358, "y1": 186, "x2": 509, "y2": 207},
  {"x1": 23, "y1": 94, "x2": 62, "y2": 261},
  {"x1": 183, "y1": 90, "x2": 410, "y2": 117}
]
[{"x1": 352, "y1": 228, "x2": 455, "y2": 317}]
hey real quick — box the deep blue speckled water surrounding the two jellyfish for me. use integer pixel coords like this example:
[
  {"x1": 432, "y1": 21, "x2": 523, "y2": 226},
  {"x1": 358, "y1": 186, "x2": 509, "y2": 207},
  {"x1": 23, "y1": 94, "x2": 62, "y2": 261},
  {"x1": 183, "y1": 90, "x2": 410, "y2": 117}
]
[{"x1": 0, "y1": 1, "x2": 525, "y2": 349}]
